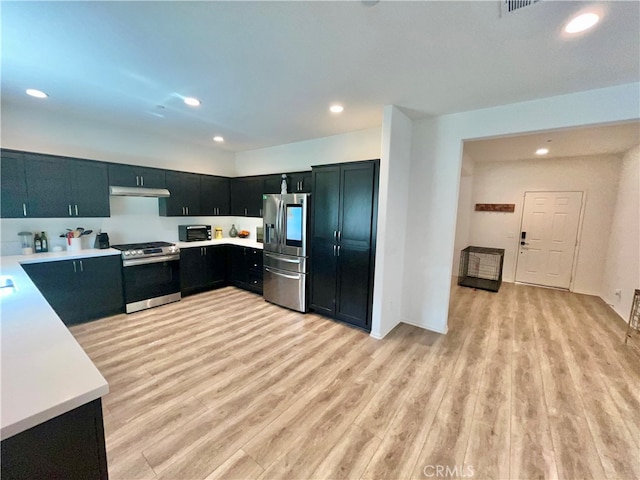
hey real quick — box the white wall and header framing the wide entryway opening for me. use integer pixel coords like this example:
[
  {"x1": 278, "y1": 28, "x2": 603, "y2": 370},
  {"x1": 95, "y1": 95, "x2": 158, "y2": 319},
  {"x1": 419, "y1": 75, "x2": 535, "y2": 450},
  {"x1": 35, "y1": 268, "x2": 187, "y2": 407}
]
[{"x1": 402, "y1": 83, "x2": 640, "y2": 332}]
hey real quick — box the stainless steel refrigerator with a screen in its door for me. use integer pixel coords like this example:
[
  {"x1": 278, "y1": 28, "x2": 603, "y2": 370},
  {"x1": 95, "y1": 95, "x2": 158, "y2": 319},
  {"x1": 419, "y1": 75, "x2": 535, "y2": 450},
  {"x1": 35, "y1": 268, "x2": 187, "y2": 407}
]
[{"x1": 262, "y1": 193, "x2": 311, "y2": 312}]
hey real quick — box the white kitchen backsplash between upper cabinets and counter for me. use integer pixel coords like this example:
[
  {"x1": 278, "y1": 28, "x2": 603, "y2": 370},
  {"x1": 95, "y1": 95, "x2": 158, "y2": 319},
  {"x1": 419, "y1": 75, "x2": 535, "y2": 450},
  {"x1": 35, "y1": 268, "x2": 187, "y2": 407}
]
[{"x1": 0, "y1": 197, "x2": 262, "y2": 256}]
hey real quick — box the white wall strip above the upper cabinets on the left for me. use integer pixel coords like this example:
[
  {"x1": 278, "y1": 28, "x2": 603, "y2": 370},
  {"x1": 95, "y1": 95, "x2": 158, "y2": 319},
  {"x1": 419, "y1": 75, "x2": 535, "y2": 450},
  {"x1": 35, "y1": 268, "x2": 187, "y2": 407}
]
[{"x1": 1, "y1": 104, "x2": 235, "y2": 176}]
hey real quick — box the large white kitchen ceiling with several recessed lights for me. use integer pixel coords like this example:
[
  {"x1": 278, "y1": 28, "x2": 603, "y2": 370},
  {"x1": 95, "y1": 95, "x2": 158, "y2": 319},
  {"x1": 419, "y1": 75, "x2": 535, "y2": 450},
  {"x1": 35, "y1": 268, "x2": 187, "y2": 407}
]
[{"x1": 1, "y1": 0, "x2": 640, "y2": 151}]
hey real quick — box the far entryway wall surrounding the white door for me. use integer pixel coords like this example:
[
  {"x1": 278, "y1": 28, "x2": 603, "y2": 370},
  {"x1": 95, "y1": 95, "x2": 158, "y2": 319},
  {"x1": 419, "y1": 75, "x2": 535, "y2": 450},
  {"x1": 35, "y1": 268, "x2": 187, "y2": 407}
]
[{"x1": 469, "y1": 155, "x2": 620, "y2": 295}]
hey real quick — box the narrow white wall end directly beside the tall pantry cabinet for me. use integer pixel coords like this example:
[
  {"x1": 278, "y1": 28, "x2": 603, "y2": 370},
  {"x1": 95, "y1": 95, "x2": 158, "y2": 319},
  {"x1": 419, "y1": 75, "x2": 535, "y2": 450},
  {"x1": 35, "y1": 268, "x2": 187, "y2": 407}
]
[{"x1": 371, "y1": 105, "x2": 412, "y2": 338}]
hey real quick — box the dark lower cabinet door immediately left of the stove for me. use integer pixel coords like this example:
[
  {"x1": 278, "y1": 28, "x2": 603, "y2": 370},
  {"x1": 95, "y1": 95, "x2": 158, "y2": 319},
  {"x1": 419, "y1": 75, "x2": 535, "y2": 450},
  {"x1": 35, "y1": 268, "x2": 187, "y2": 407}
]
[{"x1": 76, "y1": 255, "x2": 124, "y2": 322}]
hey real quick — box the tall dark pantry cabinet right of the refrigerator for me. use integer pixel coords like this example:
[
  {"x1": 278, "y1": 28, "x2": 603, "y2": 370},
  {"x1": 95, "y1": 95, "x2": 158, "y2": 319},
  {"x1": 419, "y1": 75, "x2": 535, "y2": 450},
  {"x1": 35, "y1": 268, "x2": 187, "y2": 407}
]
[{"x1": 311, "y1": 160, "x2": 379, "y2": 330}]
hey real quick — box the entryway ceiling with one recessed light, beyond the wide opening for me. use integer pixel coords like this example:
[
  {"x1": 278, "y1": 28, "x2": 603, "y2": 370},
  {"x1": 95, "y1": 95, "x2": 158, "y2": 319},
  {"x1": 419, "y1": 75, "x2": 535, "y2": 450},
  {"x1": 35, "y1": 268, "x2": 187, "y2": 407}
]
[{"x1": 464, "y1": 122, "x2": 640, "y2": 162}]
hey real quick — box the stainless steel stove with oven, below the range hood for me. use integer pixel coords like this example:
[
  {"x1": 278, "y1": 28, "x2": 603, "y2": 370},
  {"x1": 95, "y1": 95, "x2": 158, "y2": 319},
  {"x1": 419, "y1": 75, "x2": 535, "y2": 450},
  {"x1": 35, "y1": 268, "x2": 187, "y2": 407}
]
[{"x1": 112, "y1": 242, "x2": 181, "y2": 313}]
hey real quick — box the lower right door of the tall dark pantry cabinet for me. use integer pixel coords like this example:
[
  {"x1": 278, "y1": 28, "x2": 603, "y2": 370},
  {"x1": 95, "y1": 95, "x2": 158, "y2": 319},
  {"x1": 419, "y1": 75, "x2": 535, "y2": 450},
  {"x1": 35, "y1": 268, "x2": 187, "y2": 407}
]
[{"x1": 335, "y1": 244, "x2": 371, "y2": 328}]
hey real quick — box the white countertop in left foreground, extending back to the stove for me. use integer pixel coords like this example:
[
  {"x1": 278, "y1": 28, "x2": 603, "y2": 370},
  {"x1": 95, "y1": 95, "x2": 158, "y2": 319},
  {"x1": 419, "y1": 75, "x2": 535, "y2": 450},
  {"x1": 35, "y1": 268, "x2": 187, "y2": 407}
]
[{"x1": 0, "y1": 249, "x2": 115, "y2": 440}]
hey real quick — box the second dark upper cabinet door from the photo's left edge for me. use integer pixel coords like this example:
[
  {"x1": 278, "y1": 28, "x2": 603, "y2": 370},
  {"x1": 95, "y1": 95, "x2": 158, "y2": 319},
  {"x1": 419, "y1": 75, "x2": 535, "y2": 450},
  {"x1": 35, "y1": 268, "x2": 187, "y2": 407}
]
[{"x1": 25, "y1": 154, "x2": 75, "y2": 218}]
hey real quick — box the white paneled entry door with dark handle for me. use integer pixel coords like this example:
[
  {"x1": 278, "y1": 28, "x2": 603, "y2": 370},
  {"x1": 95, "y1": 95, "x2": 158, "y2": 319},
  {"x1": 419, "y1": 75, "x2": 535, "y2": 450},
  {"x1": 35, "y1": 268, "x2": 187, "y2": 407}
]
[{"x1": 516, "y1": 192, "x2": 582, "y2": 289}]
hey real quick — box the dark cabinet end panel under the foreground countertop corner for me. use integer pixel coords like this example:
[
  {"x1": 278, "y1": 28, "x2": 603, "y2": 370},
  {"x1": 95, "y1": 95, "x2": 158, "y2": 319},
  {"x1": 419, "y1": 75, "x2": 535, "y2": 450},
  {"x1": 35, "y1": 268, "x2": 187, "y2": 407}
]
[{"x1": 0, "y1": 399, "x2": 109, "y2": 480}]
